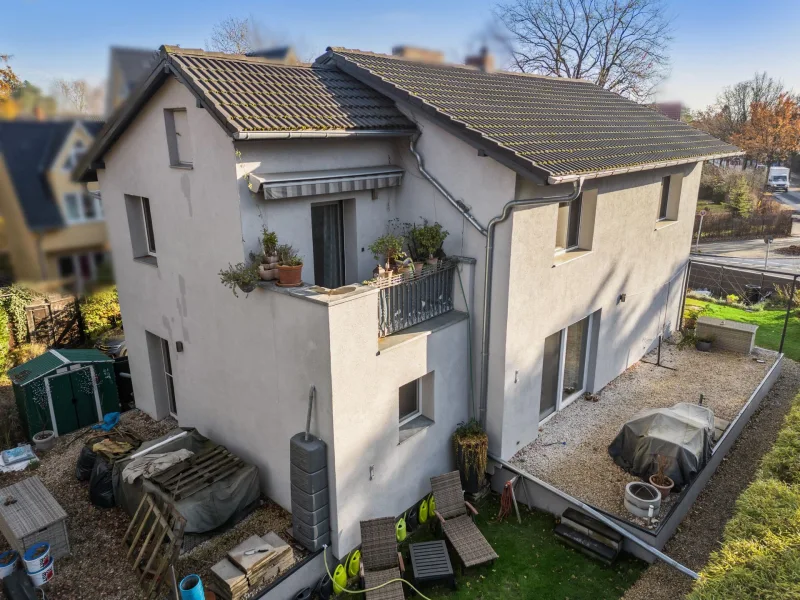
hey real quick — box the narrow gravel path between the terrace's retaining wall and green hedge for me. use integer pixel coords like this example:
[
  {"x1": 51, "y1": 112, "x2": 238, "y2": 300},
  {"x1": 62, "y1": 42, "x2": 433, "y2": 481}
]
[{"x1": 623, "y1": 359, "x2": 800, "y2": 600}]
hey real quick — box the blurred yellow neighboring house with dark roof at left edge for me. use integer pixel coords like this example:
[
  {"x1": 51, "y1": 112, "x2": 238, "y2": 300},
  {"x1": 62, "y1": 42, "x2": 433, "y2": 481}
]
[{"x1": 0, "y1": 119, "x2": 109, "y2": 284}]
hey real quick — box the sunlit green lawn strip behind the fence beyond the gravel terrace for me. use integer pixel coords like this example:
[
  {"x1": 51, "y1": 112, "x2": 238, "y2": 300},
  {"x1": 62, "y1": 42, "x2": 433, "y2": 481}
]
[{"x1": 686, "y1": 298, "x2": 800, "y2": 361}]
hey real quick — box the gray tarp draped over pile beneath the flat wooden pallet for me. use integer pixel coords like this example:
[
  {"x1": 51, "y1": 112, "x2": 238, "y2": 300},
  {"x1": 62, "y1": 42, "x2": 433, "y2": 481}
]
[{"x1": 113, "y1": 429, "x2": 261, "y2": 533}]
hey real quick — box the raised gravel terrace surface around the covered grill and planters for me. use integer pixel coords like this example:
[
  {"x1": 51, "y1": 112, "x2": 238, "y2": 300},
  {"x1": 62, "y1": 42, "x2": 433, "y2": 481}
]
[{"x1": 511, "y1": 344, "x2": 776, "y2": 525}]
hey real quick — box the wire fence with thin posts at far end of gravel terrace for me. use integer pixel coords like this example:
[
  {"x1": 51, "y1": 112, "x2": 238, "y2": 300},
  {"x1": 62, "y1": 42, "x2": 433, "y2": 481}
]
[{"x1": 680, "y1": 260, "x2": 800, "y2": 361}]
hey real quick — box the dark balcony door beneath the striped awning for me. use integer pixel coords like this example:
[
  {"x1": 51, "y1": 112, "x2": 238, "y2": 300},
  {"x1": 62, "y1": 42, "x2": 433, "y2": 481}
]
[{"x1": 311, "y1": 200, "x2": 345, "y2": 288}]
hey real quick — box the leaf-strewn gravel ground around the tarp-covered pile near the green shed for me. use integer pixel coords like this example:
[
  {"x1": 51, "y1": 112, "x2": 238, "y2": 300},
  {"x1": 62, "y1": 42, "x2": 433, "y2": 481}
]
[{"x1": 0, "y1": 406, "x2": 302, "y2": 600}]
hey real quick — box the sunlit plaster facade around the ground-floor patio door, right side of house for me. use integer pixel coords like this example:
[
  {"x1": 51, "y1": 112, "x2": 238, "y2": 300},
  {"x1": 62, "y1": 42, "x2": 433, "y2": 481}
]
[{"x1": 489, "y1": 164, "x2": 701, "y2": 458}]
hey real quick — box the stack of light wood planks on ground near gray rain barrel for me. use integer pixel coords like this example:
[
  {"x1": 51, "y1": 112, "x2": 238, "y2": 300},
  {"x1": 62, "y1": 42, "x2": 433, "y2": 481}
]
[{"x1": 209, "y1": 532, "x2": 294, "y2": 600}]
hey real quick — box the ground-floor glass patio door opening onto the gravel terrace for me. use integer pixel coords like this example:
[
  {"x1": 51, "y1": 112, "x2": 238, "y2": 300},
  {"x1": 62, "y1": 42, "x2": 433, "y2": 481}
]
[{"x1": 539, "y1": 315, "x2": 592, "y2": 421}]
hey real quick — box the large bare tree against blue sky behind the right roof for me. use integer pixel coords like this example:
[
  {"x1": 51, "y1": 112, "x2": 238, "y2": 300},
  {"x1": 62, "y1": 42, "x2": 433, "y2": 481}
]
[{"x1": 495, "y1": 0, "x2": 672, "y2": 101}]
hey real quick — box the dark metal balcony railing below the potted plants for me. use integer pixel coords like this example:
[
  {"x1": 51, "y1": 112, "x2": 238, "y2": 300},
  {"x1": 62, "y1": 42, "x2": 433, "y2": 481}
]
[{"x1": 372, "y1": 260, "x2": 458, "y2": 337}]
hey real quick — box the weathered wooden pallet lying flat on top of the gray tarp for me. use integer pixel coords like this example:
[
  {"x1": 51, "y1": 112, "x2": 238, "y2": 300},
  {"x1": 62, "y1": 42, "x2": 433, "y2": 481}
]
[{"x1": 150, "y1": 446, "x2": 244, "y2": 500}]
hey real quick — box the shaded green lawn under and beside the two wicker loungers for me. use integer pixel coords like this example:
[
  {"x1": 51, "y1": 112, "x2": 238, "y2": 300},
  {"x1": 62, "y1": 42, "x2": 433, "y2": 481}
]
[{"x1": 403, "y1": 495, "x2": 647, "y2": 600}]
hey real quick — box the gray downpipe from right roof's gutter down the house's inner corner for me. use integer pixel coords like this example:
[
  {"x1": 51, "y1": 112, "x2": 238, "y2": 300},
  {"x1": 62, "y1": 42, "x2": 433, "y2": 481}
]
[{"x1": 478, "y1": 177, "x2": 583, "y2": 430}]
